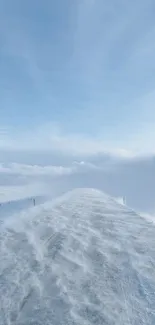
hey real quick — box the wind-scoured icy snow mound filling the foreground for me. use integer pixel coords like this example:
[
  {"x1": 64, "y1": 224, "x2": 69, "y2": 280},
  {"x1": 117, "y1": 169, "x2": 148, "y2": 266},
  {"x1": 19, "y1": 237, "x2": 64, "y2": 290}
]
[{"x1": 0, "y1": 189, "x2": 155, "y2": 325}]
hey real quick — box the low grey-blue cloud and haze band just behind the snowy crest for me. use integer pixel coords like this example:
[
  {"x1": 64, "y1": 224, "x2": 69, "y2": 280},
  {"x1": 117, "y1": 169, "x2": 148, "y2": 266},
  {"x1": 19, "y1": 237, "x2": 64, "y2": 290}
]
[{"x1": 0, "y1": 154, "x2": 155, "y2": 213}]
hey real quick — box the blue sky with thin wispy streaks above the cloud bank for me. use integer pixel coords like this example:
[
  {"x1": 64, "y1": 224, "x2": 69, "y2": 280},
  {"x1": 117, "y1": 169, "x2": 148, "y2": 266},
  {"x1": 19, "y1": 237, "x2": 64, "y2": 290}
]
[{"x1": 0, "y1": 0, "x2": 155, "y2": 152}]
